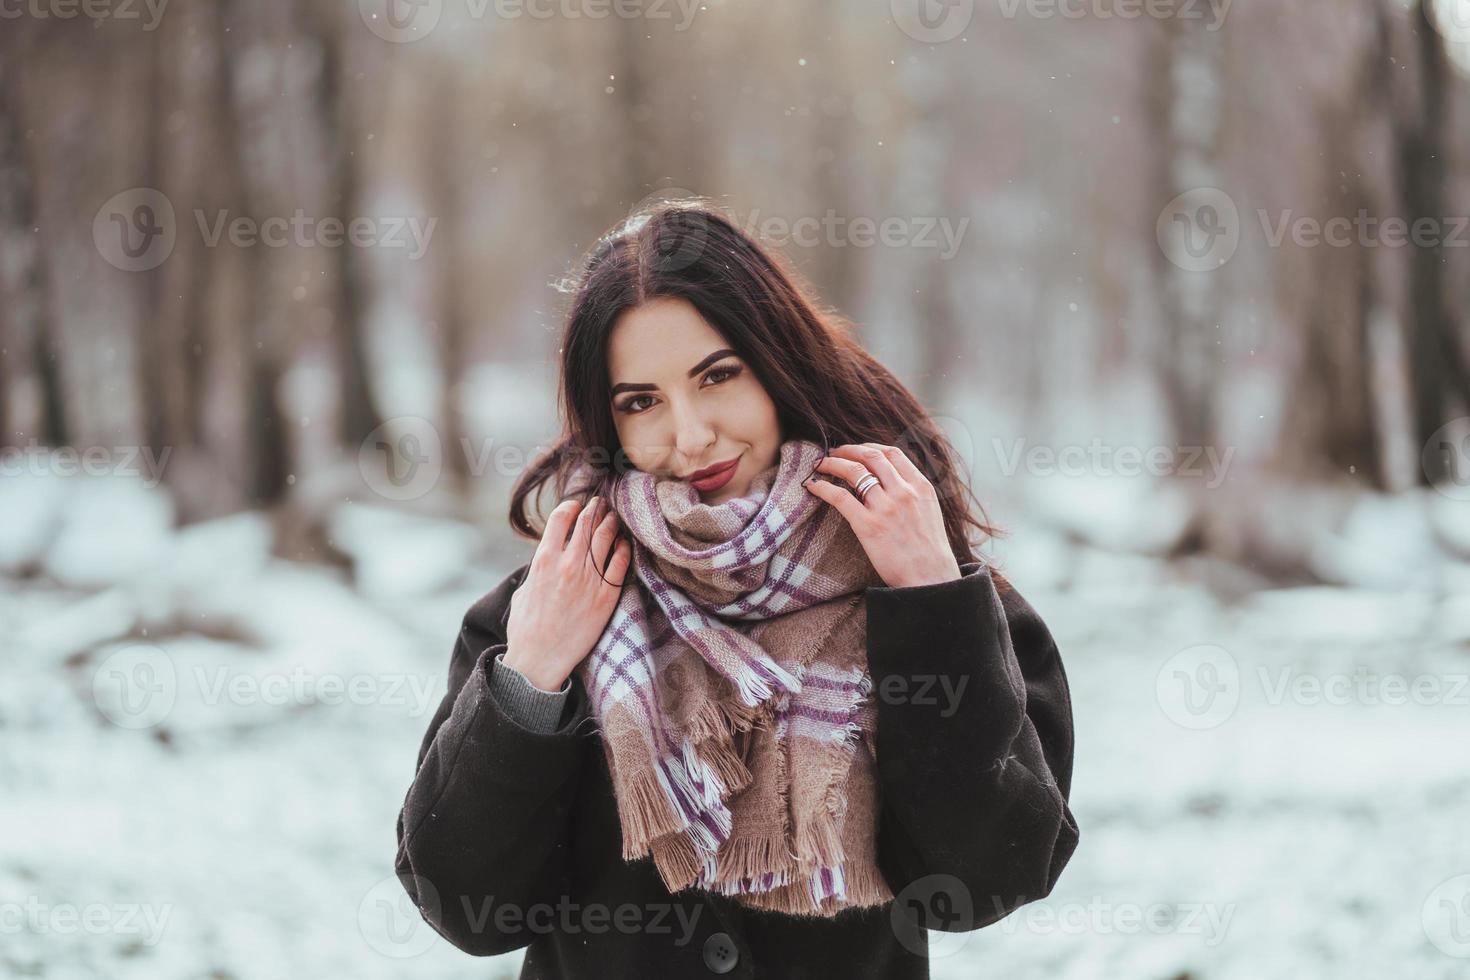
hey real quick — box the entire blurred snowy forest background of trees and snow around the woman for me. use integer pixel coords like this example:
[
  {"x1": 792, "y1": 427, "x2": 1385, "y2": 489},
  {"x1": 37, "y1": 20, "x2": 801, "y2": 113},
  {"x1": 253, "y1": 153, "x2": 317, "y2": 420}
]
[{"x1": 0, "y1": 0, "x2": 1470, "y2": 980}]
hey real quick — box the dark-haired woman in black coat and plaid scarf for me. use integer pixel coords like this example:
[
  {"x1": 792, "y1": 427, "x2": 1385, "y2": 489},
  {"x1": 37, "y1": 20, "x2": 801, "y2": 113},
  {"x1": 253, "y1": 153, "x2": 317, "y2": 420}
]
[{"x1": 397, "y1": 203, "x2": 1078, "y2": 979}]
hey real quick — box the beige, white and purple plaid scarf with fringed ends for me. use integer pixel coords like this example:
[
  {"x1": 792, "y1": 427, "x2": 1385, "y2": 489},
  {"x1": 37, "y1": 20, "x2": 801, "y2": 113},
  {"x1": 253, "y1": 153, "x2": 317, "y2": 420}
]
[{"x1": 578, "y1": 439, "x2": 894, "y2": 915}]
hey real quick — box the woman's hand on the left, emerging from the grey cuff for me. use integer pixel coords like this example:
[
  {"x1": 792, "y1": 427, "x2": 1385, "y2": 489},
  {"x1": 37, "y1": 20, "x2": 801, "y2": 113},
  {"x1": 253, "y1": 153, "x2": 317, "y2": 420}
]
[{"x1": 504, "y1": 497, "x2": 632, "y2": 691}]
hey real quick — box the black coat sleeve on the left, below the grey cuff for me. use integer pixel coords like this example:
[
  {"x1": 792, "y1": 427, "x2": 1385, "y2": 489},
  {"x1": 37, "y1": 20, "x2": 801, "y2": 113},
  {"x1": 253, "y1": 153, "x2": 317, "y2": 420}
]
[{"x1": 394, "y1": 573, "x2": 588, "y2": 956}]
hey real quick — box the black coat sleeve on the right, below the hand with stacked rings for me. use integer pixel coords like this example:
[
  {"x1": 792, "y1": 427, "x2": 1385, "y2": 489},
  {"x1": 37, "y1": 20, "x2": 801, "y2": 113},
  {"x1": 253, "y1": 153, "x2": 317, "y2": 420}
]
[{"x1": 867, "y1": 561, "x2": 1078, "y2": 932}]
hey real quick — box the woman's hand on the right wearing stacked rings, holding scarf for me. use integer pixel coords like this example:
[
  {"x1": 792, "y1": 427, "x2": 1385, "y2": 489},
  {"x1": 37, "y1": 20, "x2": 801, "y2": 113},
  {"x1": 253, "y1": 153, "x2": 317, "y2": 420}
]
[{"x1": 804, "y1": 442, "x2": 960, "y2": 588}]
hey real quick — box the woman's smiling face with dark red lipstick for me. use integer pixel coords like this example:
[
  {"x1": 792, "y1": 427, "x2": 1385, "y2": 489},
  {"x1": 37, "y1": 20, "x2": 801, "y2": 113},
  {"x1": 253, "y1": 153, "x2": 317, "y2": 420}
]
[{"x1": 607, "y1": 297, "x2": 782, "y2": 504}]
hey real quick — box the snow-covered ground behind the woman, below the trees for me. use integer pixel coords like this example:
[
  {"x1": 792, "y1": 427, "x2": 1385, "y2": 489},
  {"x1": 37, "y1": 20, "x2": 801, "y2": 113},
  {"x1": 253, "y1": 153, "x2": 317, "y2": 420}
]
[{"x1": 0, "y1": 476, "x2": 1470, "y2": 980}]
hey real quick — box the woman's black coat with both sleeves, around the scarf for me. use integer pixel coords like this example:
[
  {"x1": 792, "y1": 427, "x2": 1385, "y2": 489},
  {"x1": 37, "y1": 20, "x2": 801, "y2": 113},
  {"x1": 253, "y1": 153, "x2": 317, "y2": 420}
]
[{"x1": 395, "y1": 563, "x2": 1078, "y2": 980}]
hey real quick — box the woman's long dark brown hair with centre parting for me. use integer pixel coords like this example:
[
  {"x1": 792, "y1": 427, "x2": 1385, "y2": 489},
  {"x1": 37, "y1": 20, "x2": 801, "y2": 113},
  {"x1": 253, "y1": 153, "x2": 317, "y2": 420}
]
[{"x1": 510, "y1": 198, "x2": 1005, "y2": 581}]
